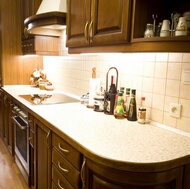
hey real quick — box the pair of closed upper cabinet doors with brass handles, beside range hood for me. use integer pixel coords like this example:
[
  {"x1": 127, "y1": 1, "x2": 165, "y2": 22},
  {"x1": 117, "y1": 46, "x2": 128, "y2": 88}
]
[{"x1": 67, "y1": 0, "x2": 132, "y2": 47}]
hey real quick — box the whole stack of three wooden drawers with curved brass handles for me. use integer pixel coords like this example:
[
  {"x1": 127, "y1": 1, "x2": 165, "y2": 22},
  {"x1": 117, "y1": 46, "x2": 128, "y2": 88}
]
[{"x1": 52, "y1": 133, "x2": 82, "y2": 189}]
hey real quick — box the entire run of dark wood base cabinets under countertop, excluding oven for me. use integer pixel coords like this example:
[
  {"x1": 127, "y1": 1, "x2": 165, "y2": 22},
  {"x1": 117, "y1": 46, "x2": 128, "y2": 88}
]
[{"x1": 0, "y1": 90, "x2": 190, "y2": 189}]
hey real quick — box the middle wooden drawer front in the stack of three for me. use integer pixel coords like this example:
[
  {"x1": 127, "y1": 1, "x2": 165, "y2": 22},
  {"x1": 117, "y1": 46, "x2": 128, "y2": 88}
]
[{"x1": 52, "y1": 148, "x2": 81, "y2": 188}]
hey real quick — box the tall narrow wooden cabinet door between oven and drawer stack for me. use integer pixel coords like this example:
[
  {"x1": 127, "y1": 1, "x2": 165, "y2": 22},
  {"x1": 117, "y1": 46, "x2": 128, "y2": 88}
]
[{"x1": 34, "y1": 119, "x2": 51, "y2": 189}]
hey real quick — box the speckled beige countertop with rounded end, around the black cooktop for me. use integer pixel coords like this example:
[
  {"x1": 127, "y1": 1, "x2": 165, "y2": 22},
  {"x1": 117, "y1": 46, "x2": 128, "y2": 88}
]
[{"x1": 3, "y1": 85, "x2": 190, "y2": 169}]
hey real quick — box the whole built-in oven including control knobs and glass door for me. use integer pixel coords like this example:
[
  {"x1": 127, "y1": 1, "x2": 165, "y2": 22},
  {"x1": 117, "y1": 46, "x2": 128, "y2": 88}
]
[{"x1": 12, "y1": 104, "x2": 30, "y2": 186}]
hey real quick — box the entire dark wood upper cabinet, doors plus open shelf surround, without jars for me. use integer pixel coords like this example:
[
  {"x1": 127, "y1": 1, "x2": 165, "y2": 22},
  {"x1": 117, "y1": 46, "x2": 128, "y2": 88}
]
[{"x1": 67, "y1": 0, "x2": 190, "y2": 53}]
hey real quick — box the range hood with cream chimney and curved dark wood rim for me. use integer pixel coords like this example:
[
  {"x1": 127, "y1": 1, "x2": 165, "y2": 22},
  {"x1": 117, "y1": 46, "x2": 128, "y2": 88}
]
[{"x1": 24, "y1": 0, "x2": 66, "y2": 36}]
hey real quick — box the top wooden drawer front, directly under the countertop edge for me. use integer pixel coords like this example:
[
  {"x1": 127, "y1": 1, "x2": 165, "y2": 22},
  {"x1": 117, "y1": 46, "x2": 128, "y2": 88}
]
[{"x1": 52, "y1": 133, "x2": 82, "y2": 170}]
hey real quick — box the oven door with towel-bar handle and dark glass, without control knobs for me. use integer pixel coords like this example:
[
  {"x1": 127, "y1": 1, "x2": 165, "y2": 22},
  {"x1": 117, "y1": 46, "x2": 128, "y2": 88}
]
[{"x1": 12, "y1": 116, "x2": 29, "y2": 175}]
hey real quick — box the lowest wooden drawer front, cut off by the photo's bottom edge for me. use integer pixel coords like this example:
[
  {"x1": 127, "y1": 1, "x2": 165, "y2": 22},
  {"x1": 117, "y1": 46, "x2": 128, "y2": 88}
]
[{"x1": 52, "y1": 166, "x2": 74, "y2": 189}]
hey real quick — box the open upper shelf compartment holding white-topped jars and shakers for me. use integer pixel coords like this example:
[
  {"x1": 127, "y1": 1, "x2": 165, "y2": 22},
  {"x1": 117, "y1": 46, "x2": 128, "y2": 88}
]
[{"x1": 132, "y1": 0, "x2": 190, "y2": 42}]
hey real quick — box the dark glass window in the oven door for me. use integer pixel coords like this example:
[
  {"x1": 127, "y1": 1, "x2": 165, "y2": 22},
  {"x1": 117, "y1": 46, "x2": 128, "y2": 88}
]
[{"x1": 16, "y1": 126, "x2": 27, "y2": 162}]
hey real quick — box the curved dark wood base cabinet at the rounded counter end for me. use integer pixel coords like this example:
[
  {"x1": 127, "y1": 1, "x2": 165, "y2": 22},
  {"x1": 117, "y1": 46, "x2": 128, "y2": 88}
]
[{"x1": 82, "y1": 158, "x2": 187, "y2": 189}]
